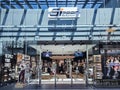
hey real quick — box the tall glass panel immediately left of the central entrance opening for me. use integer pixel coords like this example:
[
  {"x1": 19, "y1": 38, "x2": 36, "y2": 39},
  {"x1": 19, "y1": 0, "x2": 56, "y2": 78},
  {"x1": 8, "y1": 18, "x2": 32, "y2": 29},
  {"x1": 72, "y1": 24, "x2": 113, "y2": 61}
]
[{"x1": 19, "y1": 41, "x2": 40, "y2": 84}]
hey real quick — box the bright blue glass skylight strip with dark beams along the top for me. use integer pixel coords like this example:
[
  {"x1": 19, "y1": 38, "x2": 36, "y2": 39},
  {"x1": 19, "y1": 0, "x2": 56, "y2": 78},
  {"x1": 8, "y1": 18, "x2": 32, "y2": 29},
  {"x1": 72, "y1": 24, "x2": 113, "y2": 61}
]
[{"x1": 0, "y1": 0, "x2": 110, "y2": 9}]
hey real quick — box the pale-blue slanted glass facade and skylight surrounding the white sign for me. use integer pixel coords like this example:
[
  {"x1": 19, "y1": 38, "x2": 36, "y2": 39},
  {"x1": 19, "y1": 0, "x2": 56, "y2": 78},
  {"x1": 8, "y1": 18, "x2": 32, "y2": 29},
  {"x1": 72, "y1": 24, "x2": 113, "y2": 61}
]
[{"x1": 0, "y1": 0, "x2": 120, "y2": 44}]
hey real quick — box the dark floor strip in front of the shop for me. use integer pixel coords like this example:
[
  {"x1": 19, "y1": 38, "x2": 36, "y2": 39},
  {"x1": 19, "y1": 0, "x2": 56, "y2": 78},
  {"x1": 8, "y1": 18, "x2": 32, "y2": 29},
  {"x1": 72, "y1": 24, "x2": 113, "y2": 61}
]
[{"x1": 0, "y1": 84, "x2": 120, "y2": 90}]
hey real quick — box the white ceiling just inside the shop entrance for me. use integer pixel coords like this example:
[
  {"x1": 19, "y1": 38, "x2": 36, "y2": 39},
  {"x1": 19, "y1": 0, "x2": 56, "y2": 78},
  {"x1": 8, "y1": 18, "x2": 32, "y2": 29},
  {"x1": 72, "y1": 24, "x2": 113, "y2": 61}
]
[{"x1": 30, "y1": 44, "x2": 95, "y2": 55}]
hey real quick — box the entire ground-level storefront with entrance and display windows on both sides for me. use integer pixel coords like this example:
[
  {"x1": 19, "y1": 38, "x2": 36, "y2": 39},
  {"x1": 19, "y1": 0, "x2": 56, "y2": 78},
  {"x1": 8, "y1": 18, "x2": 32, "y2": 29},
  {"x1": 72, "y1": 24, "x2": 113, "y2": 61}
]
[{"x1": 0, "y1": 42, "x2": 120, "y2": 87}]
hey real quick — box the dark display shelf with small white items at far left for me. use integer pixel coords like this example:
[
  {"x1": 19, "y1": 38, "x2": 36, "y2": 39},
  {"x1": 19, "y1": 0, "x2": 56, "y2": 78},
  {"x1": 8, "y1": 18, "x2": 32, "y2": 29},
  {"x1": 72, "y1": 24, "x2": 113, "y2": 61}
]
[{"x1": 1, "y1": 54, "x2": 15, "y2": 83}]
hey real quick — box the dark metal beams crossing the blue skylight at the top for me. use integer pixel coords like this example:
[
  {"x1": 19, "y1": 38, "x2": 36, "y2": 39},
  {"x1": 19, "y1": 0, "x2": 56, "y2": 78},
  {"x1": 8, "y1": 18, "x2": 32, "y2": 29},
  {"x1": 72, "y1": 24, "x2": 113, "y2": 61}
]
[{"x1": 1, "y1": 0, "x2": 106, "y2": 9}]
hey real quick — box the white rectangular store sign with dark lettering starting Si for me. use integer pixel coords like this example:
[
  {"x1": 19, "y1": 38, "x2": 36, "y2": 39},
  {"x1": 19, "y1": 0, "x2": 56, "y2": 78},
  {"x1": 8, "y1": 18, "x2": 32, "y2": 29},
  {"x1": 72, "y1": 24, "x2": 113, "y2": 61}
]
[{"x1": 48, "y1": 7, "x2": 80, "y2": 18}]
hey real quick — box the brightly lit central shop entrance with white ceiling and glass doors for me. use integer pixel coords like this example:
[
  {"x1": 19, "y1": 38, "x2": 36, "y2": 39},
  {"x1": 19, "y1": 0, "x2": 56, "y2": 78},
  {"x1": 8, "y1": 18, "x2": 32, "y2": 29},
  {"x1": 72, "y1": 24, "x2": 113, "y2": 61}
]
[{"x1": 29, "y1": 45, "x2": 94, "y2": 85}]
